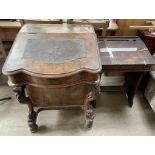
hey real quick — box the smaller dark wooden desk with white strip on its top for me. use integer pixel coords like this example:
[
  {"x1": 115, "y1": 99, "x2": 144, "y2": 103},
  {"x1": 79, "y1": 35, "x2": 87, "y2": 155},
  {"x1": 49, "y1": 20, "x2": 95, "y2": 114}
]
[{"x1": 98, "y1": 36, "x2": 155, "y2": 107}]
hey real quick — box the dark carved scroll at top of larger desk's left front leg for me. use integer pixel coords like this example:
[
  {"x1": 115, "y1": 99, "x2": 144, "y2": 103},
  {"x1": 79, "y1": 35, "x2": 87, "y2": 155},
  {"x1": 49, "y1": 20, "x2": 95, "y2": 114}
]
[{"x1": 13, "y1": 86, "x2": 30, "y2": 104}]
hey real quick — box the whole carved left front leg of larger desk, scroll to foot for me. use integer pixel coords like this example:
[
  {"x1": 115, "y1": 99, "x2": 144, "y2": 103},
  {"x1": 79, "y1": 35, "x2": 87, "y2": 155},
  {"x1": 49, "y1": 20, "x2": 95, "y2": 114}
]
[{"x1": 13, "y1": 86, "x2": 38, "y2": 133}]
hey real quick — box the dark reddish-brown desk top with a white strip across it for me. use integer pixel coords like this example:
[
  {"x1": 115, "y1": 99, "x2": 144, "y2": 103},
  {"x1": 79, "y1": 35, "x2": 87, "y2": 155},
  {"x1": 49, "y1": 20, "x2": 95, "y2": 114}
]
[{"x1": 98, "y1": 36, "x2": 155, "y2": 71}]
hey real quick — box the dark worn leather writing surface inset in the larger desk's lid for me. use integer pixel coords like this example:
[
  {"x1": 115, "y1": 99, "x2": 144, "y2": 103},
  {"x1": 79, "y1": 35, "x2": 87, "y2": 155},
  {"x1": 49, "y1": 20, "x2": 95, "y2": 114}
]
[{"x1": 23, "y1": 39, "x2": 86, "y2": 64}]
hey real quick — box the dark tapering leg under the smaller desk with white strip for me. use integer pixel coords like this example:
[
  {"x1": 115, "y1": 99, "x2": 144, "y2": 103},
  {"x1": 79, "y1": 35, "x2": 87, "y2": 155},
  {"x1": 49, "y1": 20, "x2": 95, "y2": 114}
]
[{"x1": 124, "y1": 72, "x2": 146, "y2": 107}]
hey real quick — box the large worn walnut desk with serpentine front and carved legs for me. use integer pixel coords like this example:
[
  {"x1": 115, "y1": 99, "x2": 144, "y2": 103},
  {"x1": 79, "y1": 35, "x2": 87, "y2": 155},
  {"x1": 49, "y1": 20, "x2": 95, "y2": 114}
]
[{"x1": 3, "y1": 24, "x2": 102, "y2": 132}]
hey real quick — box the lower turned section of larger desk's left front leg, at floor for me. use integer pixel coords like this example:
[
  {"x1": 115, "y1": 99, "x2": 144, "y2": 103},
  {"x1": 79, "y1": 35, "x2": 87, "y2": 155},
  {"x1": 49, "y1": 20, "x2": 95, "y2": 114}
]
[{"x1": 28, "y1": 110, "x2": 38, "y2": 133}]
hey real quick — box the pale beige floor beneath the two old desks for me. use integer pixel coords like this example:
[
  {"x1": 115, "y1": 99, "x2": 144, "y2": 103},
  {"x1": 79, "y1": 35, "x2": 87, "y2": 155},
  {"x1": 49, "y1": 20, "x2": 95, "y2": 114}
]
[{"x1": 0, "y1": 85, "x2": 155, "y2": 136}]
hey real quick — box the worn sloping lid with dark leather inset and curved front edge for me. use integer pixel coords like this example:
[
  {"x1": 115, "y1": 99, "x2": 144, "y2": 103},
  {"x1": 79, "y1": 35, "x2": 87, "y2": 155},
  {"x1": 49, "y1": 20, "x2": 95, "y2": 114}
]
[{"x1": 3, "y1": 24, "x2": 101, "y2": 77}]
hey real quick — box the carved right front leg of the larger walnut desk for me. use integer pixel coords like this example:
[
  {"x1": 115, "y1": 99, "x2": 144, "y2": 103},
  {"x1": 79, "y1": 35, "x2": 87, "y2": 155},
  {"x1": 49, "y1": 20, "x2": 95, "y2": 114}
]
[{"x1": 84, "y1": 92, "x2": 96, "y2": 128}]
